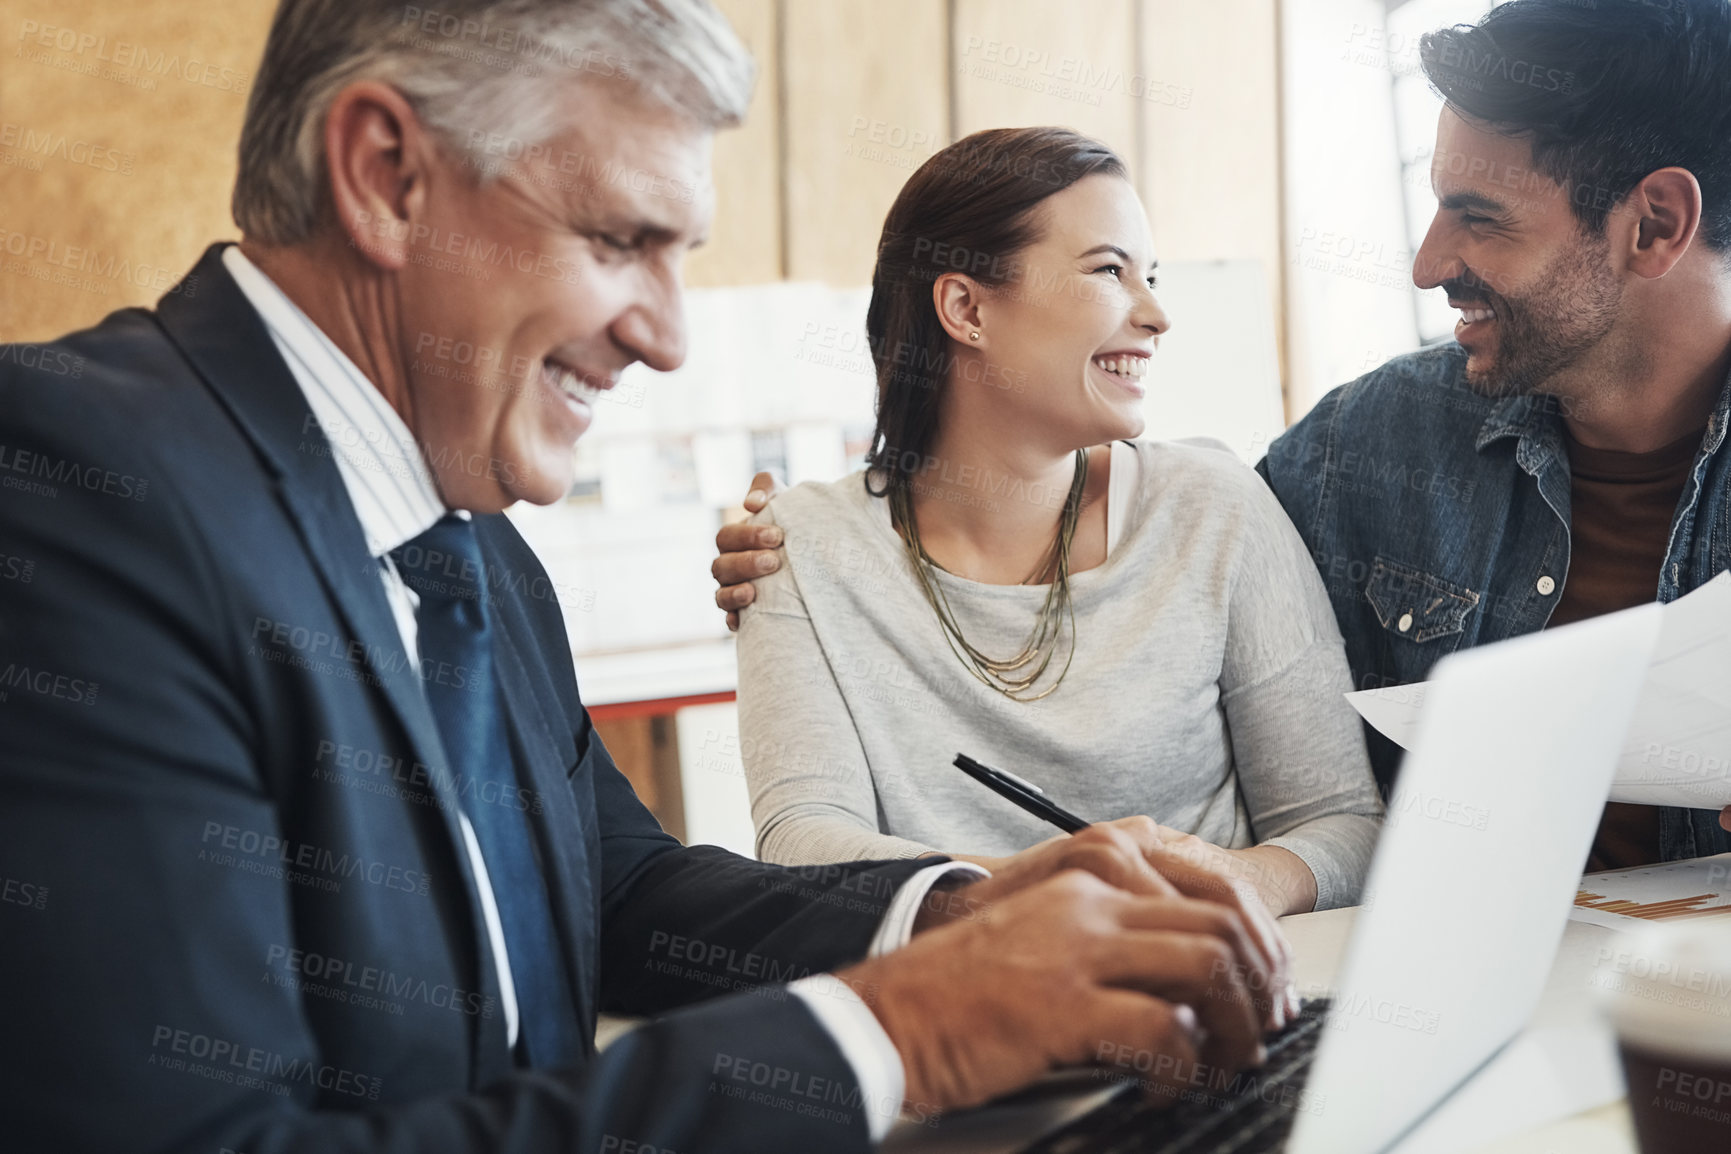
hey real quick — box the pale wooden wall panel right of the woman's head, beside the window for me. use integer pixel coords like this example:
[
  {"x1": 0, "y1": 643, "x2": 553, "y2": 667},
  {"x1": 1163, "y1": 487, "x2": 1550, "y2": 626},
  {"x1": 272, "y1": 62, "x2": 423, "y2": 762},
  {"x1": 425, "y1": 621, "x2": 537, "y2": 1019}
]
[{"x1": 1141, "y1": 0, "x2": 1286, "y2": 387}]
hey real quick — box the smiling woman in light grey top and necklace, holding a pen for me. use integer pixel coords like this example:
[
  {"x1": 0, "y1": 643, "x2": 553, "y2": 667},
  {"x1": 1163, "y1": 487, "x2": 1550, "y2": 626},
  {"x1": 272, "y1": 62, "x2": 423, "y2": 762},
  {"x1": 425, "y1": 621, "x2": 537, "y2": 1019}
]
[{"x1": 739, "y1": 128, "x2": 1380, "y2": 914}]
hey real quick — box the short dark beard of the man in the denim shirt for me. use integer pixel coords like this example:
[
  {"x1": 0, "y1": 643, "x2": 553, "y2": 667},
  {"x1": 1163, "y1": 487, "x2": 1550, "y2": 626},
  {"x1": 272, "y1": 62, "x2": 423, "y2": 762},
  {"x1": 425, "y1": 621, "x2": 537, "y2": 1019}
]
[{"x1": 1442, "y1": 237, "x2": 1622, "y2": 396}]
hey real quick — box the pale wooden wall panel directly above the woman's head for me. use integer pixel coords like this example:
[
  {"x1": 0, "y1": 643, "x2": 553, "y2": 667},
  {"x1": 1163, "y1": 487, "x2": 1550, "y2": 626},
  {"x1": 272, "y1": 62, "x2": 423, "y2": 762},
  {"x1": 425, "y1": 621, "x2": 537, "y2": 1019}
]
[{"x1": 952, "y1": 0, "x2": 1142, "y2": 173}]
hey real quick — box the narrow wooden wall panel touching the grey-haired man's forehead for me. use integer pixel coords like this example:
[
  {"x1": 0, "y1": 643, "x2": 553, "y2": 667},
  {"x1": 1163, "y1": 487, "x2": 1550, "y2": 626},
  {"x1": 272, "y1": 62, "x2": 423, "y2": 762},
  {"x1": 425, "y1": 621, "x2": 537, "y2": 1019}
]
[{"x1": 685, "y1": 0, "x2": 782, "y2": 287}]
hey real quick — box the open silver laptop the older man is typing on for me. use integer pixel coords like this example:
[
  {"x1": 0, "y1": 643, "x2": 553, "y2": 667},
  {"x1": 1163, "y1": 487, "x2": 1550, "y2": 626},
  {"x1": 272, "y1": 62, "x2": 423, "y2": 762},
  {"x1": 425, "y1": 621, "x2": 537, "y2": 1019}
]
[{"x1": 1023, "y1": 604, "x2": 1660, "y2": 1154}]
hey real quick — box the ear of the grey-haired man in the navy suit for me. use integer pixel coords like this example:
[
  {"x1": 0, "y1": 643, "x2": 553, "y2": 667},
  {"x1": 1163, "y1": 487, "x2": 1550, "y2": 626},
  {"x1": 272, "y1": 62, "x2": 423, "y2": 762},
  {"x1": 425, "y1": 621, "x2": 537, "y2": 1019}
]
[{"x1": 324, "y1": 80, "x2": 433, "y2": 272}]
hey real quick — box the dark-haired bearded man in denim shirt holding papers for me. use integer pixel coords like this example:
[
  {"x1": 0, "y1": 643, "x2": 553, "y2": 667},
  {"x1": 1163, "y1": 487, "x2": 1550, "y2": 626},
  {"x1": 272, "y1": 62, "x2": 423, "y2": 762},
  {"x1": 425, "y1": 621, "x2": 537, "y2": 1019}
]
[{"x1": 1258, "y1": 0, "x2": 1731, "y2": 869}]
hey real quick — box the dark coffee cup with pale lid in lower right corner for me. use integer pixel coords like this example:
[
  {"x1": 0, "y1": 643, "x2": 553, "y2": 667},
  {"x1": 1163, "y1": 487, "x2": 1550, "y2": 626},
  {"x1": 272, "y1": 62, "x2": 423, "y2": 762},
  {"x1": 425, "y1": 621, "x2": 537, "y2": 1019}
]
[{"x1": 1594, "y1": 919, "x2": 1731, "y2": 1154}]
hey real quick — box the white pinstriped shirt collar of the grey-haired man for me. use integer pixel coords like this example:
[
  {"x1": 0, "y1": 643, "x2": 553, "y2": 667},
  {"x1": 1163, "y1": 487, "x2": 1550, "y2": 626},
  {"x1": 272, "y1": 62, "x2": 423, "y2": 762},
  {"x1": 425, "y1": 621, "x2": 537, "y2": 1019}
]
[{"x1": 222, "y1": 246, "x2": 445, "y2": 557}]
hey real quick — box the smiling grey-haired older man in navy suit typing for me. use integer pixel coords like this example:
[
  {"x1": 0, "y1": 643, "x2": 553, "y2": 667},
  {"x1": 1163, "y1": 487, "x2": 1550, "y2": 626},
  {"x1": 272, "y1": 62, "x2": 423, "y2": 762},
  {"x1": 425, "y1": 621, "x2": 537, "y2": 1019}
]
[{"x1": 0, "y1": 0, "x2": 1290, "y2": 1154}]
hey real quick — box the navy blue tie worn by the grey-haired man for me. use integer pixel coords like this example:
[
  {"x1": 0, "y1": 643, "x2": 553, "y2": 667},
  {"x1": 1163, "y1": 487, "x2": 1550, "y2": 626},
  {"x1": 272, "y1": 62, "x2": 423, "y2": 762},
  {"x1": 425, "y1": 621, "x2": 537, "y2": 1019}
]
[{"x1": 391, "y1": 514, "x2": 582, "y2": 1067}]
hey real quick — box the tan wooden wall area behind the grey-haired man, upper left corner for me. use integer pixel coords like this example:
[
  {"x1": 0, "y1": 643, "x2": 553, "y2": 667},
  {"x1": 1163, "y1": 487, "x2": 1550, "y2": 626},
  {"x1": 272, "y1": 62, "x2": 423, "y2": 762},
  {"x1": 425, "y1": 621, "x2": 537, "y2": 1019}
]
[{"x1": 0, "y1": 0, "x2": 275, "y2": 341}]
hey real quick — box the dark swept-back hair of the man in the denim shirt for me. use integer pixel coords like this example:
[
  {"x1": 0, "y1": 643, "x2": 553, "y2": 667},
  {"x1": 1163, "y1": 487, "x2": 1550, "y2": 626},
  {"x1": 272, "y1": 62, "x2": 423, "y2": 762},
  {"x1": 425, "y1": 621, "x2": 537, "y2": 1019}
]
[{"x1": 1419, "y1": 0, "x2": 1731, "y2": 253}]
